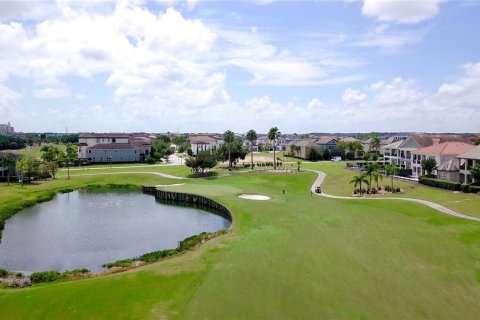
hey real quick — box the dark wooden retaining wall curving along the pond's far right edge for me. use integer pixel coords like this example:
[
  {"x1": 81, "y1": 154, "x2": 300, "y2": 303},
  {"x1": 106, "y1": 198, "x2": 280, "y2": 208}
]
[{"x1": 142, "y1": 186, "x2": 232, "y2": 222}]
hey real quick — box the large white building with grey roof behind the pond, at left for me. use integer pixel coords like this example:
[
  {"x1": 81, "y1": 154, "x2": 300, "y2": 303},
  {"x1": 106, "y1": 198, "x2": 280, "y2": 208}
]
[{"x1": 78, "y1": 133, "x2": 151, "y2": 163}]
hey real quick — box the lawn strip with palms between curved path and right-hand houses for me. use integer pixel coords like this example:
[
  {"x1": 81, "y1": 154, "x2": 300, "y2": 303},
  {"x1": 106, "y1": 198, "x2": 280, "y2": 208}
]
[{"x1": 302, "y1": 162, "x2": 480, "y2": 217}]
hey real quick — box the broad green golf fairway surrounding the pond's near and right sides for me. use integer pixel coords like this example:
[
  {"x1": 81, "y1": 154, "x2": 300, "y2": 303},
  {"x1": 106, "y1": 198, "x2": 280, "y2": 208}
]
[{"x1": 0, "y1": 164, "x2": 480, "y2": 319}]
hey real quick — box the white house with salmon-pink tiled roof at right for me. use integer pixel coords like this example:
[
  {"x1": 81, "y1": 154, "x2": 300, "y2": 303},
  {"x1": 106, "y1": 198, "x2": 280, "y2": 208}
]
[{"x1": 411, "y1": 142, "x2": 474, "y2": 182}]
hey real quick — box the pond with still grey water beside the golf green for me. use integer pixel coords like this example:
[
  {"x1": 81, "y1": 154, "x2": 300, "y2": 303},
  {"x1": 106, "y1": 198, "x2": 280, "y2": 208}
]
[{"x1": 0, "y1": 190, "x2": 230, "y2": 272}]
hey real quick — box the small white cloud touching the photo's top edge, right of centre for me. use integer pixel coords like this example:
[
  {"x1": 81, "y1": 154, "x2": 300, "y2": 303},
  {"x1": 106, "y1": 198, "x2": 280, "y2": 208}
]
[{"x1": 362, "y1": 0, "x2": 441, "y2": 24}]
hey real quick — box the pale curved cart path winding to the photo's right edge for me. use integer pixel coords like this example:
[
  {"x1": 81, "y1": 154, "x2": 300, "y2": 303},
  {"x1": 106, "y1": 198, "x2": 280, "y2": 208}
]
[{"x1": 306, "y1": 169, "x2": 480, "y2": 221}]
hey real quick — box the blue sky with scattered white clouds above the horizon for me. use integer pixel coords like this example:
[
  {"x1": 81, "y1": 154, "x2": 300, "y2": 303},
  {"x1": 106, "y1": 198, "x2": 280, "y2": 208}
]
[{"x1": 0, "y1": 0, "x2": 480, "y2": 133}]
